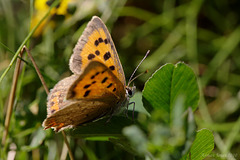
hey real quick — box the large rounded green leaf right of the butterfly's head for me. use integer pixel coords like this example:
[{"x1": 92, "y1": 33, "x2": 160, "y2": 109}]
[{"x1": 143, "y1": 62, "x2": 199, "y2": 113}]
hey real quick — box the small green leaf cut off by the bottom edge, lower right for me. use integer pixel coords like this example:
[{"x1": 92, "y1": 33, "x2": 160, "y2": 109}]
[{"x1": 181, "y1": 129, "x2": 214, "y2": 160}]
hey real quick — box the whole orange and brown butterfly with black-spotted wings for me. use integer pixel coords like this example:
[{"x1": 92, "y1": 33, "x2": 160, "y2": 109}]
[{"x1": 43, "y1": 16, "x2": 135, "y2": 132}]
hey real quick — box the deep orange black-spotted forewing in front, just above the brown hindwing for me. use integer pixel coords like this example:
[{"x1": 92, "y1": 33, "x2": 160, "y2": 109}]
[{"x1": 67, "y1": 61, "x2": 125, "y2": 100}]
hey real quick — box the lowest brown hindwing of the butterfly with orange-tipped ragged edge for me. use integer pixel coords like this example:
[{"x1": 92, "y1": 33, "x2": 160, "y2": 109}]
[{"x1": 43, "y1": 100, "x2": 116, "y2": 132}]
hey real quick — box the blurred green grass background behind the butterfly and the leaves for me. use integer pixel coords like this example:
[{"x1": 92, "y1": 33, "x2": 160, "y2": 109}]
[{"x1": 0, "y1": 0, "x2": 240, "y2": 159}]
